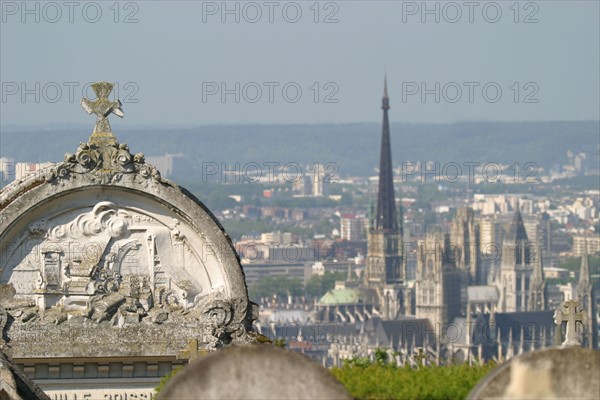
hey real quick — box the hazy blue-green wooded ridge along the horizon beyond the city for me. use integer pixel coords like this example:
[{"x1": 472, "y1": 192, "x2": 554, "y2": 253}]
[{"x1": 0, "y1": 121, "x2": 600, "y2": 177}]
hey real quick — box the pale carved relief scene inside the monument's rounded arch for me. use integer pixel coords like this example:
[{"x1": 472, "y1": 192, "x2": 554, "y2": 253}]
[{"x1": 0, "y1": 201, "x2": 231, "y2": 326}]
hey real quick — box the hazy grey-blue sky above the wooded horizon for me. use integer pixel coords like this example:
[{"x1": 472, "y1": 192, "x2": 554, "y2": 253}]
[{"x1": 0, "y1": 1, "x2": 600, "y2": 127}]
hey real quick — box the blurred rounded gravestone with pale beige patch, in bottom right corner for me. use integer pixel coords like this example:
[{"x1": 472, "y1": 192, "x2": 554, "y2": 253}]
[{"x1": 468, "y1": 347, "x2": 600, "y2": 400}]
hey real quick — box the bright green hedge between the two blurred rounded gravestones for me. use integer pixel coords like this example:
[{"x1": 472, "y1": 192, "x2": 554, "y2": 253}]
[{"x1": 331, "y1": 363, "x2": 494, "y2": 400}]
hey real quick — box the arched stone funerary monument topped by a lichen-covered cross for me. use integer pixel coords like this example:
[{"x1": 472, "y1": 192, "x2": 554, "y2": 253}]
[{"x1": 0, "y1": 82, "x2": 257, "y2": 400}]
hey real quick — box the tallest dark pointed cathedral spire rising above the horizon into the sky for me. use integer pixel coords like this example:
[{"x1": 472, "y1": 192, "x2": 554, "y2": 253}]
[{"x1": 375, "y1": 76, "x2": 398, "y2": 231}]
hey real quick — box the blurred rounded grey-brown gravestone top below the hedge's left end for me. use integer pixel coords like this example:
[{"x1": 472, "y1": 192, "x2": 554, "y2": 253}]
[{"x1": 159, "y1": 345, "x2": 351, "y2": 400}]
